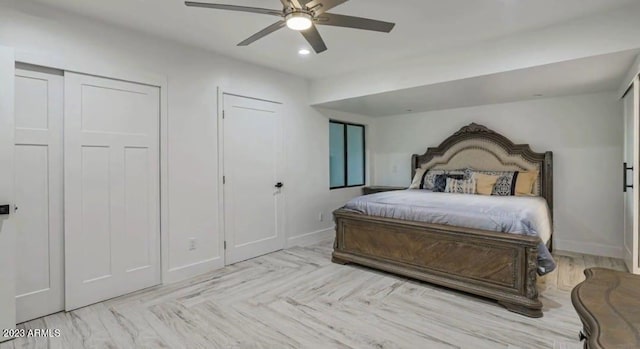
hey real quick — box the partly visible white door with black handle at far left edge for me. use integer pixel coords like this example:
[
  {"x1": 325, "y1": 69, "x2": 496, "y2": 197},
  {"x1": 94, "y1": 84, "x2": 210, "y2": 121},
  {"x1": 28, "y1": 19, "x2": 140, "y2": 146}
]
[{"x1": 0, "y1": 46, "x2": 16, "y2": 342}]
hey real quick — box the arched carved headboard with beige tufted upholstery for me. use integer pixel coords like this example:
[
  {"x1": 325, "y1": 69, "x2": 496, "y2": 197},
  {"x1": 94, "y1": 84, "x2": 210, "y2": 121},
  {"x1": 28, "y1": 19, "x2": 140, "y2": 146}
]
[{"x1": 411, "y1": 123, "x2": 553, "y2": 212}]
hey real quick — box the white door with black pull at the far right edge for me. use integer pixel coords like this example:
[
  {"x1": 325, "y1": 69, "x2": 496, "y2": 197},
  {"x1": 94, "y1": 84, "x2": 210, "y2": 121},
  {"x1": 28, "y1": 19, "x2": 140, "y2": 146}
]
[{"x1": 623, "y1": 78, "x2": 640, "y2": 274}]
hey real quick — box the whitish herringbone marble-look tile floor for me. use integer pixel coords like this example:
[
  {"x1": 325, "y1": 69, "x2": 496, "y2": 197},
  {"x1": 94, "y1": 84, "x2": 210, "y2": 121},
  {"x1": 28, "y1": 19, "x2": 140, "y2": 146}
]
[{"x1": 0, "y1": 241, "x2": 626, "y2": 349}]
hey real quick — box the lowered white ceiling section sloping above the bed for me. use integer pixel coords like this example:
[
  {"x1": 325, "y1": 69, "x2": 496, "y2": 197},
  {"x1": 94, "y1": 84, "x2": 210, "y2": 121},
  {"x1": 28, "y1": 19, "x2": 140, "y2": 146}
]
[{"x1": 315, "y1": 50, "x2": 640, "y2": 116}]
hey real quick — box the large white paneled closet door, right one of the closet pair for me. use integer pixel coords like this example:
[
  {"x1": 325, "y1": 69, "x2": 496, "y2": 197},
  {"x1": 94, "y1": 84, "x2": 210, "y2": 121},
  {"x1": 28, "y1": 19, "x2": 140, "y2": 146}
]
[{"x1": 64, "y1": 73, "x2": 160, "y2": 310}]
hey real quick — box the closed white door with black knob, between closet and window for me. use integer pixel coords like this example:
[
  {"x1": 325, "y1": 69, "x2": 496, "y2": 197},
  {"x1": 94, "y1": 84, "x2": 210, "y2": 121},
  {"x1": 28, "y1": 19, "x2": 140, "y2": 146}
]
[{"x1": 223, "y1": 94, "x2": 285, "y2": 264}]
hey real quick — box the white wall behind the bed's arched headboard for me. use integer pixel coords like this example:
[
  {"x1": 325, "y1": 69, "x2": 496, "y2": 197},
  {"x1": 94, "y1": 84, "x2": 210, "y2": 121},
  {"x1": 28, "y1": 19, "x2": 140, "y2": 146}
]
[{"x1": 372, "y1": 93, "x2": 623, "y2": 257}]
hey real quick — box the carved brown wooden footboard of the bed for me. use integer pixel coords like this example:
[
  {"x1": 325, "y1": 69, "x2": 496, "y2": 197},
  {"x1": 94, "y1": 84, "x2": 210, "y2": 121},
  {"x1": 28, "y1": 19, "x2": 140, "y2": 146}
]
[{"x1": 332, "y1": 209, "x2": 542, "y2": 317}]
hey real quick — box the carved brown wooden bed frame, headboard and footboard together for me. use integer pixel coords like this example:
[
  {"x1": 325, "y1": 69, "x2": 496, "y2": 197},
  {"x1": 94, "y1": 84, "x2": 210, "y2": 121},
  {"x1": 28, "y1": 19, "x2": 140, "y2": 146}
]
[{"x1": 332, "y1": 123, "x2": 553, "y2": 317}]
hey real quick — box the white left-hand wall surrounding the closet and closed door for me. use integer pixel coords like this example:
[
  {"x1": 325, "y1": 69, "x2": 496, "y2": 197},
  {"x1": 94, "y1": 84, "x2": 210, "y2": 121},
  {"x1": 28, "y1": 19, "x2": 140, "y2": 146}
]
[{"x1": 0, "y1": 2, "x2": 370, "y2": 282}]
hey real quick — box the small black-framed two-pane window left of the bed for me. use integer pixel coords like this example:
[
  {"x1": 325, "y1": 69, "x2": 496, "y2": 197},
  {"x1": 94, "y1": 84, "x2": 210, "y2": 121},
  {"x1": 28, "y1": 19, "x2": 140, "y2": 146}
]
[{"x1": 329, "y1": 120, "x2": 365, "y2": 189}]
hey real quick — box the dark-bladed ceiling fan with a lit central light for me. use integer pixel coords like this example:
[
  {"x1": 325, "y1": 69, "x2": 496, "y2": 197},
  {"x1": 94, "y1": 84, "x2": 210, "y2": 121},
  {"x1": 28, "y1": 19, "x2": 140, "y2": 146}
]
[{"x1": 185, "y1": 0, "x2": 395, "y2": 53}]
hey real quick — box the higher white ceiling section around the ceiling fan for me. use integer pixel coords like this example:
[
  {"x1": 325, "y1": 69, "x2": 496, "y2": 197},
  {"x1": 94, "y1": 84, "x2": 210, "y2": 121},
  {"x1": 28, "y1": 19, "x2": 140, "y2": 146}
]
[{"x1": 23, "y1": 0, "x2": 637, "y2": 78}]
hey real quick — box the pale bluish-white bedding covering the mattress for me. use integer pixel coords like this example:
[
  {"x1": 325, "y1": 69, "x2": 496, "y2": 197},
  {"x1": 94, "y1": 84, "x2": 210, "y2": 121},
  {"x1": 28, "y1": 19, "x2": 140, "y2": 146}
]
[{"x1": 345, "y1": 189, "x2": 556, "y2": 275}]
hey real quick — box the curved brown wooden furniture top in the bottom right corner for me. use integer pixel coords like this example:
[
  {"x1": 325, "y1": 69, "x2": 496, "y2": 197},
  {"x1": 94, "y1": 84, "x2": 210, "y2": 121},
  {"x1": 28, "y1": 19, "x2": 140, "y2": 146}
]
[{"x1": 571, "y1": 268, "x2": 640, "y2": 349}]
